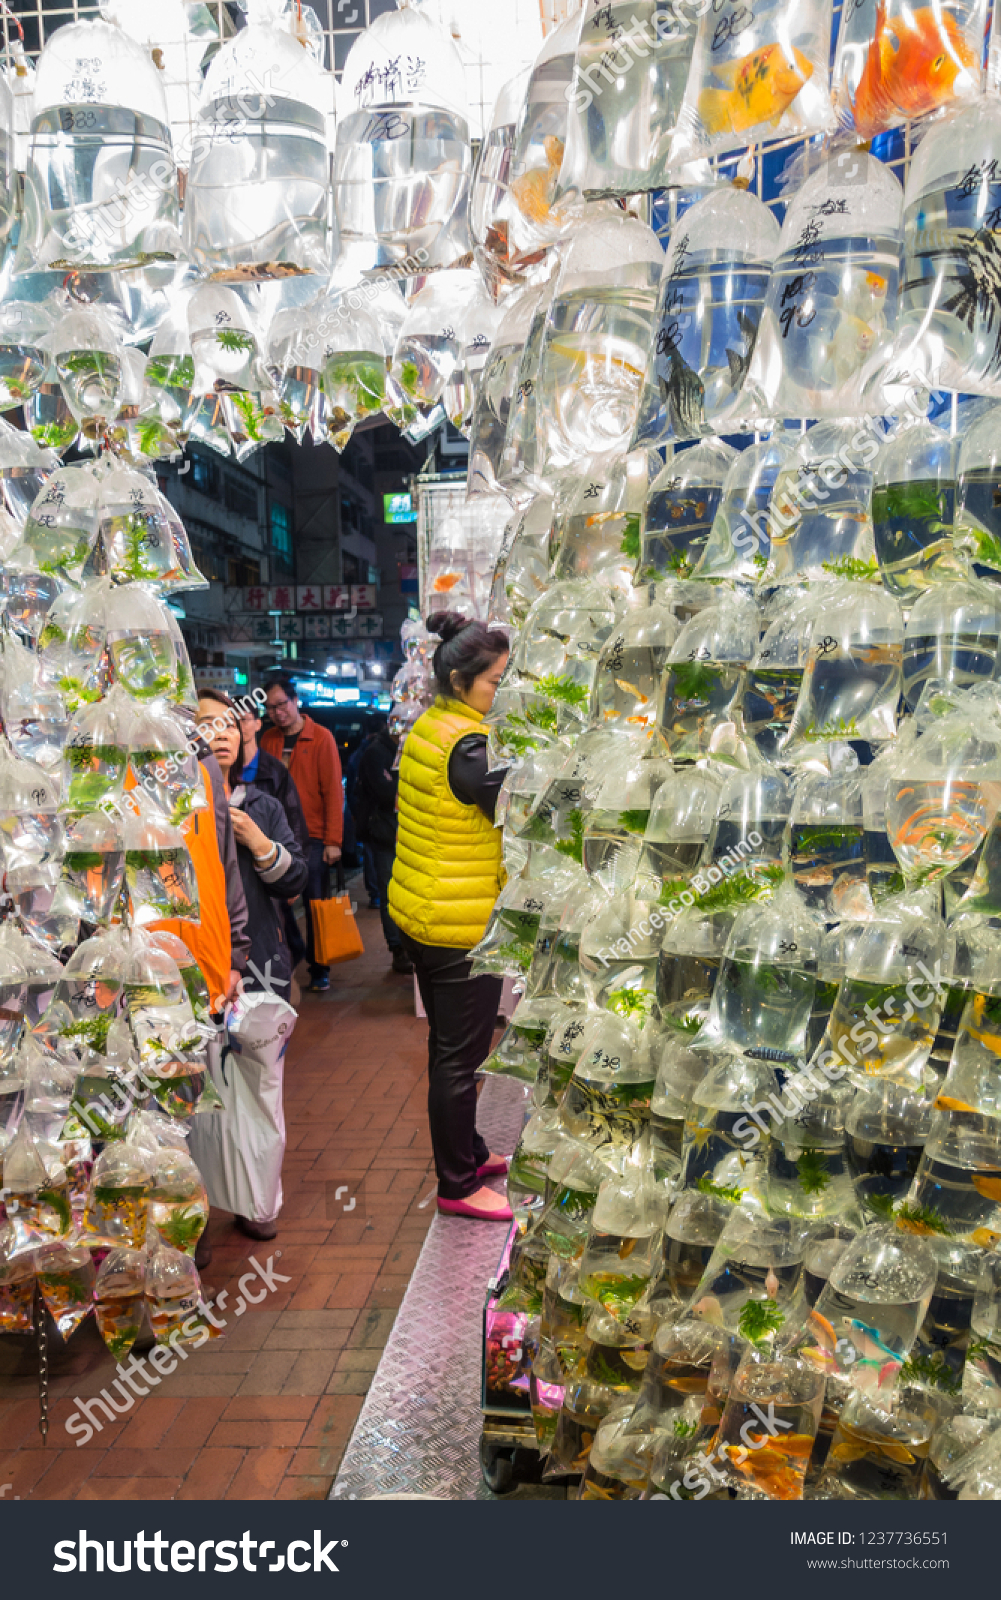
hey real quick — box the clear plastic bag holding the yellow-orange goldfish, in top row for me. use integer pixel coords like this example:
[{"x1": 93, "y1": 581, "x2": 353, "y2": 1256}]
[{"x1": 670, "y1": 0, "x2": 835, "y2": 166}]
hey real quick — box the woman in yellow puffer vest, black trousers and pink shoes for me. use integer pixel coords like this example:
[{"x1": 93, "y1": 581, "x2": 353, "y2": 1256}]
[{"x1": 389, "y1": 611, "x2": 512, "y2": 1222}]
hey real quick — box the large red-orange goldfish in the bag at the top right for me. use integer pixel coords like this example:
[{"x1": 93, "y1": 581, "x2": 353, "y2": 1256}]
[{"x1": 852, "y1": 0, "x2": 975, "y2": 139}]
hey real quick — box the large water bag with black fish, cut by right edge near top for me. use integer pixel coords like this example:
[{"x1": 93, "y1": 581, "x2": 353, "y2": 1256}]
[{"x1": 894, "y1": 99, "x2": 1001, "y2": 397}]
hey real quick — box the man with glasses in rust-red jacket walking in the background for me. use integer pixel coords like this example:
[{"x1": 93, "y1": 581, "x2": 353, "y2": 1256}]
[{"x1": 261, "y1": 672, "x2": 344, "y2": 994}]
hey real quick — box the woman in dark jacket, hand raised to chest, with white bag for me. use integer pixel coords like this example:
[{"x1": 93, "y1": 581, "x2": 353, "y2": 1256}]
[{"x1": 198, "y1": 690, "x2": 307, "y2": 1238}]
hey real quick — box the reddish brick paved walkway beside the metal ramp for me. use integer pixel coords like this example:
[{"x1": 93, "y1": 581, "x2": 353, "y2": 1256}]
[{"x1": 0, "y1": 909, "x2": 435, "y2": 1499}]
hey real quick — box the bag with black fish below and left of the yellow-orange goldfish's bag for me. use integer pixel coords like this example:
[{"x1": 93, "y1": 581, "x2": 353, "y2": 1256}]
[{"x1": 636, "y1": 186, "x2": 779, "y2": 443}]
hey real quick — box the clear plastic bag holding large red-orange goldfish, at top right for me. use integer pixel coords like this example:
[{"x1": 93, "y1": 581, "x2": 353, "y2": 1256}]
[{"x1": 832, "y1": 0, "x2": 987, "y2": 139}]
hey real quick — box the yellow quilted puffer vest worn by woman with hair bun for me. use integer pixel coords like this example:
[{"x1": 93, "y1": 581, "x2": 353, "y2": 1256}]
[{"x1": 389, "y1": 694, "x2": 501, "y2": 950}]
